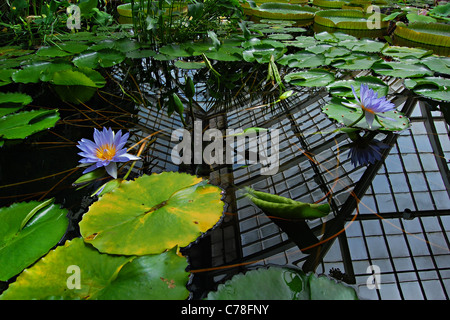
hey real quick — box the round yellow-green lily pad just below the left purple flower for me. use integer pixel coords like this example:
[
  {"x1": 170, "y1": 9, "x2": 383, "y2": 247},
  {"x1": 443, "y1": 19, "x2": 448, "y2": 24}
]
[{"x1": 80, "y1": 172, "x2": 224, "y2": 255}]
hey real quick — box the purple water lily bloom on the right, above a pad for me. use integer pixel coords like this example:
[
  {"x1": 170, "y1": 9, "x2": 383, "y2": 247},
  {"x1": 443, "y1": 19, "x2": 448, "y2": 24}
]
[{"x1": 342, "y1": 84, "x2": 396, "y2": 129}]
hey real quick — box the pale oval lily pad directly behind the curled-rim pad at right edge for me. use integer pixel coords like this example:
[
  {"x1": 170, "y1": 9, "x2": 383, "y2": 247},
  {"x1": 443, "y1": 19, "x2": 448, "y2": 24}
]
[{"x1": 371, "y1": 61, "x2": 433, "y2": 78}]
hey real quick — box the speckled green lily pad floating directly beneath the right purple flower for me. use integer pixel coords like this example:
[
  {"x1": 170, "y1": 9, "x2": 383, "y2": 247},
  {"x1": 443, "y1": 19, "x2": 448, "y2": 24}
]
[{"x1": 322, "y1": 97, "x2": 409, "y2": 131}]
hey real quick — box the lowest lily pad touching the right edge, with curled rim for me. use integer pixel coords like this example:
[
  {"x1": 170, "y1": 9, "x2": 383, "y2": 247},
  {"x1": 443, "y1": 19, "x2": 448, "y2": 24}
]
[{"x1": 405, "y1": 77, "x2": 450, "y2": 101}]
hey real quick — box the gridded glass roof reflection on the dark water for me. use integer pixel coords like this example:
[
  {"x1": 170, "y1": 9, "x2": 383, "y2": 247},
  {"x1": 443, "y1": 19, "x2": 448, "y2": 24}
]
[{"x1": 132, "y1": 68, "x2": 450, "y2": 299}]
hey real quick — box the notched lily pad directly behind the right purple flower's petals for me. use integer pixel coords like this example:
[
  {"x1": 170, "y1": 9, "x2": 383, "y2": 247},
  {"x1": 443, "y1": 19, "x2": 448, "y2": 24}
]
[{"x1": 327, "y1": 76, "x2": 389, "y2": 98}]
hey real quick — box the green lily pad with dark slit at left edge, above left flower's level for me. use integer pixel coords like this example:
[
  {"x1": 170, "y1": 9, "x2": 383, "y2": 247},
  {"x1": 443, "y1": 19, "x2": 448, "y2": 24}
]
[{"x1": 0, "y1": 110, "x2": 59, "y2": 139}]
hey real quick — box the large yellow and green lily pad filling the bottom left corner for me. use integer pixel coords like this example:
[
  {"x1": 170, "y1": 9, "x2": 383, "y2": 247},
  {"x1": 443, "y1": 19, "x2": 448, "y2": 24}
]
[{"x1": 0, "y1": 238, "x2": 189, "y2": 300}]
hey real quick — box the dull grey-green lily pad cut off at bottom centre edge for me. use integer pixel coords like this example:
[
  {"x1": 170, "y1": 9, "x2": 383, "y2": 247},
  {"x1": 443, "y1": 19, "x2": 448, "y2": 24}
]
[{"x1": 206, "y1": 267, "x2": 358, "y2": 300}]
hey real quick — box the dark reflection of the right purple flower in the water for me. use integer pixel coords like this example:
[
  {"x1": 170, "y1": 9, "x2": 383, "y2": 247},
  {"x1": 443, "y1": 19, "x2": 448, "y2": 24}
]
[{"x1": 348, "y1": 139, "x2": 389, "y2": 167}]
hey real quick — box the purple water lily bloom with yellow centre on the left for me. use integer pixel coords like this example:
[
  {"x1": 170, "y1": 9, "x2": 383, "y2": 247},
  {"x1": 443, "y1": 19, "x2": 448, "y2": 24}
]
[{"x1": 77, "y1": 128, "x2": 140, "y2": 179}]
